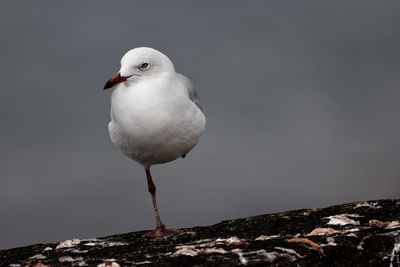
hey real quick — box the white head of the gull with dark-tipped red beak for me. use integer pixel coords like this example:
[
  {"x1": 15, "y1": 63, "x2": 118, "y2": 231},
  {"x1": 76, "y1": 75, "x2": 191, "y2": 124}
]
[{"x1": 104, "y1": 47, "x2": 175, "y2": 90}]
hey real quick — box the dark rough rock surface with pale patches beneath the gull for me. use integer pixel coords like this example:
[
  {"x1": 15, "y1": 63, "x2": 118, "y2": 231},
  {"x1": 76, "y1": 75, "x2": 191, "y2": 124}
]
[{"x1": 0, "y1": 200, "x2": 400, "y2": 267}]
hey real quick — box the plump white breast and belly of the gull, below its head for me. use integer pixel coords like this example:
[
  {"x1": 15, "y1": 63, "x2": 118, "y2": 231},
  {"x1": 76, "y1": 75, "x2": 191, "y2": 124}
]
[{"x1": 108, "y1": 74, "x2": 205, "y2": 168}]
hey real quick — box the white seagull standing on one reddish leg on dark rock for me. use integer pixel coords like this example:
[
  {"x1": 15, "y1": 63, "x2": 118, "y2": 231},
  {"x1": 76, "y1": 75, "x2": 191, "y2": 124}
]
[{"x1": 104, "y1": 47, "x2": 206, "y2": 237}]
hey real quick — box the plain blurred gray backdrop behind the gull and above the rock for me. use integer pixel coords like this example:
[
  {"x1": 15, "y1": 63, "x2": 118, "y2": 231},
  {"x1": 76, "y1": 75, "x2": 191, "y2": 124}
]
[{"x1": 0, "y1": 0, "x2": 400, "y2": 248}]
